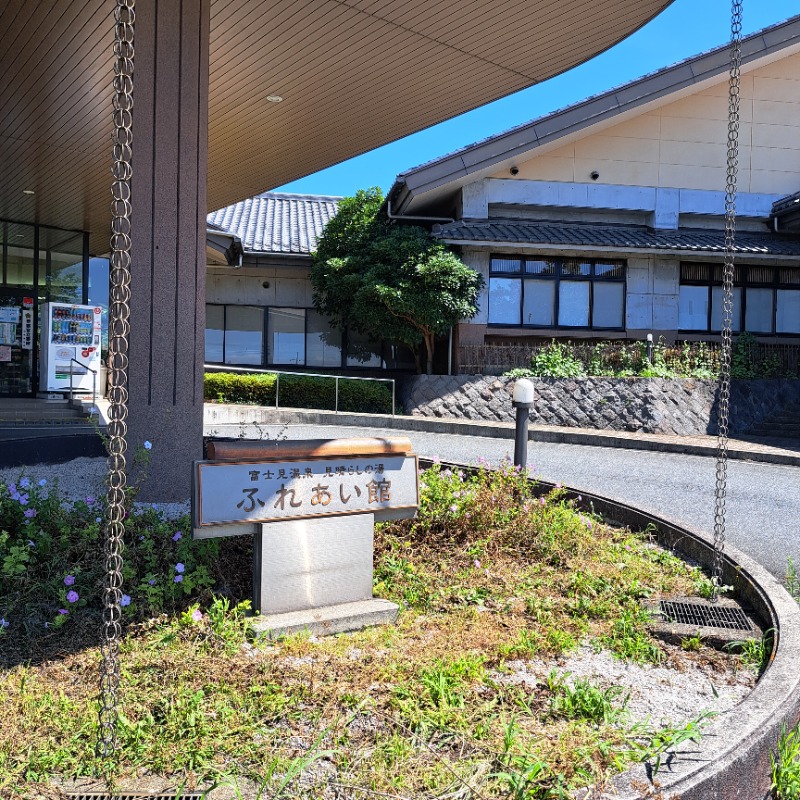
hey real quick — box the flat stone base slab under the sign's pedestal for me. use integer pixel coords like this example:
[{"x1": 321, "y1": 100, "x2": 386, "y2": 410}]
[{"x1": 251, "y1": 597, "x2": 398, "y2": 639}]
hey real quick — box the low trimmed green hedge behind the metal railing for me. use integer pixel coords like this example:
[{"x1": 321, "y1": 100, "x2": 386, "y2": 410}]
[{"x1": 204, "y1": 372, "x2": 392, "y2": 414}]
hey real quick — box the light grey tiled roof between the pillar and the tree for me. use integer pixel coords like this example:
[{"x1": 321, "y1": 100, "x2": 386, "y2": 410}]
[{"x1": 208, "y1": 192, "x2": 341, "y2": 255}]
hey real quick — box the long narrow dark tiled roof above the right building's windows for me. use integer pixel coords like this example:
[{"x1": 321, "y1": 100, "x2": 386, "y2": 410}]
[{"x1": 433, "y1": 220, "x2": 800, "y2": 256}]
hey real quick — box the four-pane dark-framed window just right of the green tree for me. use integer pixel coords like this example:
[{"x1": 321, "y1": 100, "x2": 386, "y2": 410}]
[{"x1": 489, "y1": 256, "x2": 625, "y2": 330}]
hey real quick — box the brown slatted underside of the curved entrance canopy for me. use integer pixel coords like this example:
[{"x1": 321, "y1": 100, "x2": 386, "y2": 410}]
[{"x1": 0, "y1": 0, "x2": 671, "y2": 251}]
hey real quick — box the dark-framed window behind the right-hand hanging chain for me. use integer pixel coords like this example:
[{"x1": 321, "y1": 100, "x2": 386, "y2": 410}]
[{"x1": 678, "y1": 263, "x2": 800, "y2": 336}]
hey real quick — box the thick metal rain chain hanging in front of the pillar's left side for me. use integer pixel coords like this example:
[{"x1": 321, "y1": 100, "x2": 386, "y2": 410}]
[{"x1": 97, "y1": 0, "x2": 135, "y2": 757}]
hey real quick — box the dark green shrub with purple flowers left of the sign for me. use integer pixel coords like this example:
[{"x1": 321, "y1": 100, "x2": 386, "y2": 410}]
[{"x1": 0, "y1": 475, "x2": 249, "y2": 638}]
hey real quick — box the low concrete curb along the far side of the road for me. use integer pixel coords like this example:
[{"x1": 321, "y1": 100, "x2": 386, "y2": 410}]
[{"x1": 204, "y1": 403, "x2": 800, "y2": 467}]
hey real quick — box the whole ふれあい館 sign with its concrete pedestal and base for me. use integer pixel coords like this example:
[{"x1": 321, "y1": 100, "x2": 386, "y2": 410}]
[{"x1": 192, "y1": 439, "x2": 419, "y2": 638}]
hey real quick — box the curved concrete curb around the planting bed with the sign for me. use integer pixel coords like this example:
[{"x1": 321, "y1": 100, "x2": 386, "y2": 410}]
[{"x1": 434, "y1": 459, "x2": 800, "y2": 800}]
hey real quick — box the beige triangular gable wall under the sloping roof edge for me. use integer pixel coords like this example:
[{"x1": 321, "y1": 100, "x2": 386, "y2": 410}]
[{"x1": 492, "y1": 53, "x2": 800, "y2": 194}]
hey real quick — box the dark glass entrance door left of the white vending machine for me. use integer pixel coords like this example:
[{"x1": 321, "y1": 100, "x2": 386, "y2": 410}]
[{"x1": 0, "y1": 288, "x2": 36, "y2": 397}]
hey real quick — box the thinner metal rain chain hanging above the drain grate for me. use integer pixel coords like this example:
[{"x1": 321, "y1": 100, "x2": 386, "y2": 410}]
[{"x1": 711, "y1": 0, "x2": 742, "y2": 603}]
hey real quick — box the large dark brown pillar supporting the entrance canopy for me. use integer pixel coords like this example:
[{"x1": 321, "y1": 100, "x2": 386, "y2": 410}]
[{"x1": 128, "y1": 0, "x2": 210, "y2": 502}]
